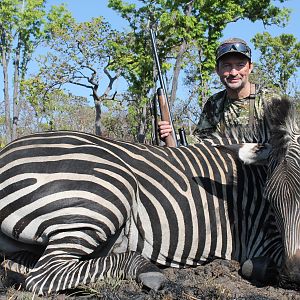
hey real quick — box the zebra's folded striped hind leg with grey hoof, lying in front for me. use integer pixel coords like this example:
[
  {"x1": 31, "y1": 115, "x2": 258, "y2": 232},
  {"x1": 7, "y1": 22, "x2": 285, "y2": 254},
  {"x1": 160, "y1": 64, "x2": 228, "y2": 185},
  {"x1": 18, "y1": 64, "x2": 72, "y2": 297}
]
[{"x1": 25, "y1": 233, "x2": 165, "y2": 295}]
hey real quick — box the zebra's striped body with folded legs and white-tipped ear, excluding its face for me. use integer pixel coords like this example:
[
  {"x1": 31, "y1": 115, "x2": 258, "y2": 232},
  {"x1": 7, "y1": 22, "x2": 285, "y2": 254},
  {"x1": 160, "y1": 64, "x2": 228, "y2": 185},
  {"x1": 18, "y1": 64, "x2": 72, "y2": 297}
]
[{"x1": 0, "y1": 97, "x2": 299, "y2": 295}]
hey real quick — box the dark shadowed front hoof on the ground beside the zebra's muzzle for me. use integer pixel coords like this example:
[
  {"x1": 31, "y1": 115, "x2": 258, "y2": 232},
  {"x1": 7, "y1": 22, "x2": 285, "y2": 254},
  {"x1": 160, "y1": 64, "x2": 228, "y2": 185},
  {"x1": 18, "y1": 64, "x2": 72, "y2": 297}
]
[{"x1": 241, "y1": 257, "x2": 278, "y2": 283}]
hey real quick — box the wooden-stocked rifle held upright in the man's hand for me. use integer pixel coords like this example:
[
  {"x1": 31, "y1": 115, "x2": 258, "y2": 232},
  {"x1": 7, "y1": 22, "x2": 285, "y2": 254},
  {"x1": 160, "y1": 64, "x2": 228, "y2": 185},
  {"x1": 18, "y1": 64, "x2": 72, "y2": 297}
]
[{"x1": 150, "y1": 27, "x2": 178, "y2": 147}]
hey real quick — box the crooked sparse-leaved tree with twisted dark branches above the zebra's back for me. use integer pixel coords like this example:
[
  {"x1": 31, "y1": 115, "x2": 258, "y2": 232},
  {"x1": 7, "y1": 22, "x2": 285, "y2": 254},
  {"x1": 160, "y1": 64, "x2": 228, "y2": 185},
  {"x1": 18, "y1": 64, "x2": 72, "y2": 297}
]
[{"x1": 29, "y1": 17, "x2": 122, "y2": 135}]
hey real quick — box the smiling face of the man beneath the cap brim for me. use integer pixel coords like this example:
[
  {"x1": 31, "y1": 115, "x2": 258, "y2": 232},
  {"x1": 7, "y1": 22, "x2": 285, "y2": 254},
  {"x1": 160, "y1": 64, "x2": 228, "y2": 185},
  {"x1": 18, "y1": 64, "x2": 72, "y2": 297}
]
[{"x1": 216, "y1": 53, "x2": 253, "y2": 90}]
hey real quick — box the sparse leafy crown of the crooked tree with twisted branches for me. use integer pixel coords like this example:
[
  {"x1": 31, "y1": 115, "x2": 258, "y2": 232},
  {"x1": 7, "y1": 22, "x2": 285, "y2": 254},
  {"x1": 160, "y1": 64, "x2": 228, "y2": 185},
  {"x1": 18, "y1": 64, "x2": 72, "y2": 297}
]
[{"x1": 44, "y1": 17, "x2": 113, "y2": 71}]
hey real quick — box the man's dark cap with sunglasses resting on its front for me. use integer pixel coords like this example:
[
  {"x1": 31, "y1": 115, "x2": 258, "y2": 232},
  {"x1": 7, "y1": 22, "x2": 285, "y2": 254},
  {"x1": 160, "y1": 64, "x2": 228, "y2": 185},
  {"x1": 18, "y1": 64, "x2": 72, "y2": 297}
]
[{"x1": 216, "y1": 38, "x2": 251, "y2": 61}]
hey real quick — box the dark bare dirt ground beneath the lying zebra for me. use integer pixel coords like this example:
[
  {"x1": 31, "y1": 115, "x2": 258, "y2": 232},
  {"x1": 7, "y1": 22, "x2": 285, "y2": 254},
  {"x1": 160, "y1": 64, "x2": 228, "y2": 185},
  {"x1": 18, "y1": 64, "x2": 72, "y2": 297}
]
[{"x1": 0, "y1": 260, "x2": 300, "y2": 300}]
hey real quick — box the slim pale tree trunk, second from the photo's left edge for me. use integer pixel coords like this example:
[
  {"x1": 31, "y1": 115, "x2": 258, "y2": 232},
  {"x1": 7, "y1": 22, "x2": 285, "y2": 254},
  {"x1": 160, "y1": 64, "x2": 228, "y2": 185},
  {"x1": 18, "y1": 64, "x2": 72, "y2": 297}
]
[{"x1": 12, "y1": 34, "x2": 21, "y2": 140}]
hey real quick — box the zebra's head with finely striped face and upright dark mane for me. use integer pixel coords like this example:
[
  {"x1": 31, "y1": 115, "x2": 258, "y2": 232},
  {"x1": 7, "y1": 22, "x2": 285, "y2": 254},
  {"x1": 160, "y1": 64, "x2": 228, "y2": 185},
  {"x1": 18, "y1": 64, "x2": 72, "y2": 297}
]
[{"x1": 264, "y1": 98, "x2": 300, "y2": 287}]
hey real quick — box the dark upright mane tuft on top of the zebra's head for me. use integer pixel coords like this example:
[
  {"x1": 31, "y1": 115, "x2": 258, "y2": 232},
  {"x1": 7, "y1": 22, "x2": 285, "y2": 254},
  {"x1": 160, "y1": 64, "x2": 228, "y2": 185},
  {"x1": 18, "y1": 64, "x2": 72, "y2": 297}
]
[{"x1": 266, "y1": 97, "x2": 299, "y2": 158}]
